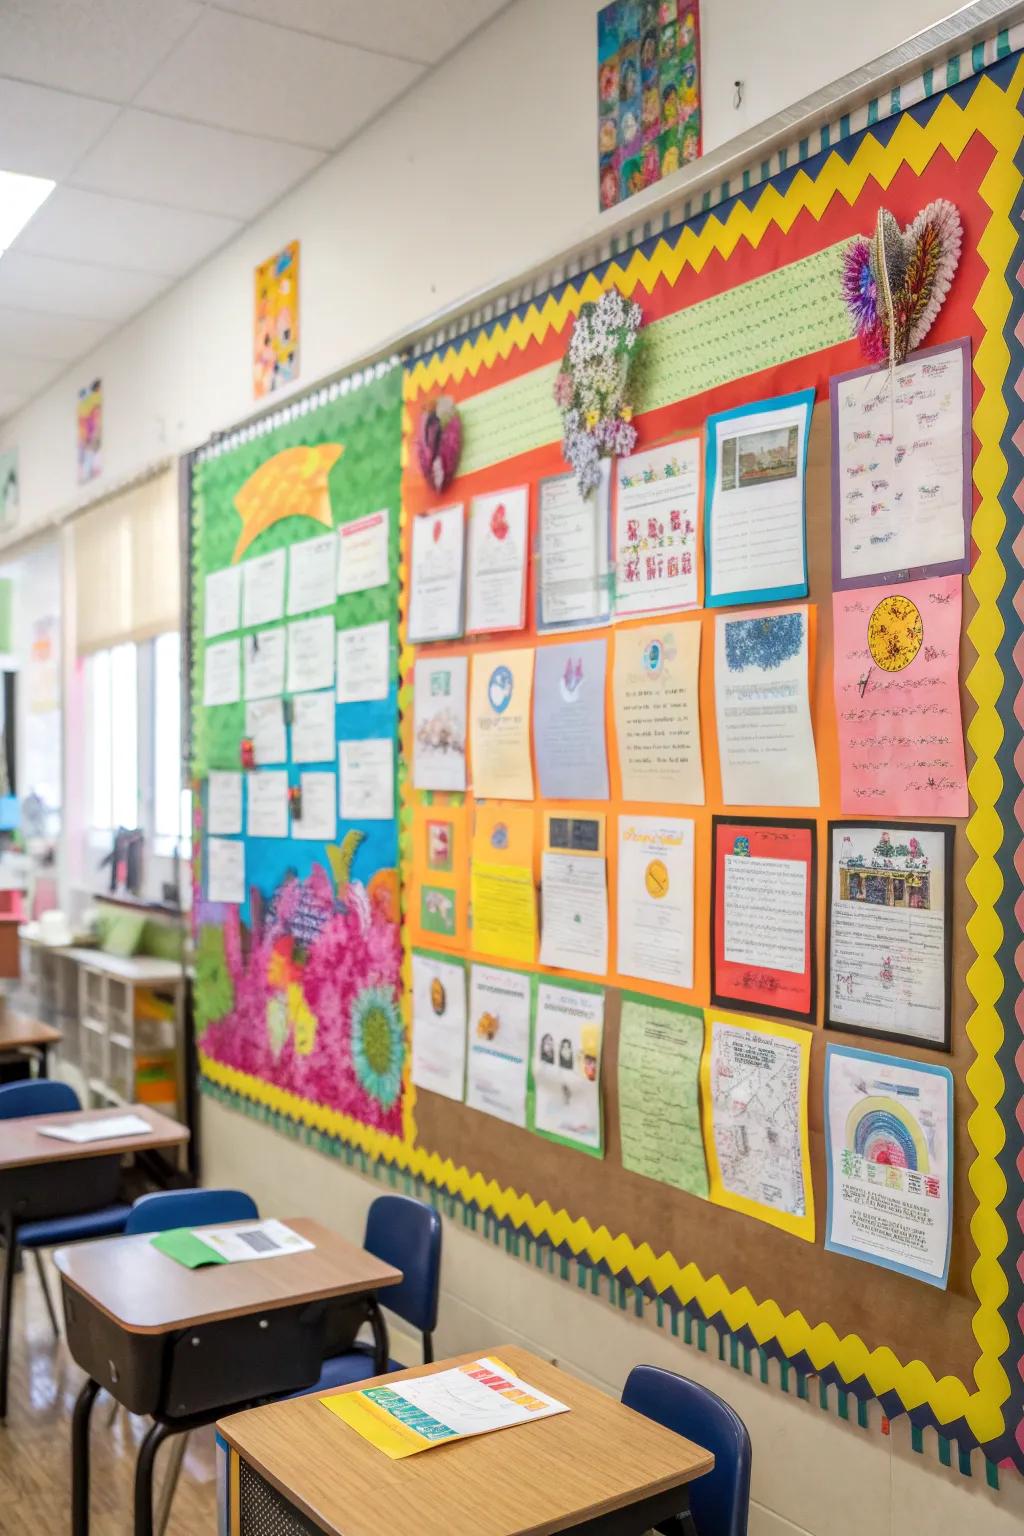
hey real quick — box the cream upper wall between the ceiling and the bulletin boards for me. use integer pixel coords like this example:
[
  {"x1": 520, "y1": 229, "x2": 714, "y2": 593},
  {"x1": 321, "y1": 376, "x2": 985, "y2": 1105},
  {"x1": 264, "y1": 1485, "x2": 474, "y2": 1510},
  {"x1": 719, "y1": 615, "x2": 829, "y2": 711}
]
[{"x1": 0, "y1": 0, "x2": 950, "y2": 536}]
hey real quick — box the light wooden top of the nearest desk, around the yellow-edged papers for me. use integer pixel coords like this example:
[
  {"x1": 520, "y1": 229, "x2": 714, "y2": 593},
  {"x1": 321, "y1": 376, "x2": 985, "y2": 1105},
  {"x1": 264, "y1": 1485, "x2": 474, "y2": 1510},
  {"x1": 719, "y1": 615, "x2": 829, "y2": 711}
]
[{"x1": 218, "y1": 1344, "x2": 714, "y2": 1536}]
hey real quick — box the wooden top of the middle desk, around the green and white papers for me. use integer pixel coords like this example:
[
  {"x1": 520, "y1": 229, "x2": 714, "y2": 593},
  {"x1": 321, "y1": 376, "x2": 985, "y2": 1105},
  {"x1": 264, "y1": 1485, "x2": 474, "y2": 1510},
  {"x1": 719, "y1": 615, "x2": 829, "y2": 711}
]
[{"x1": 54, "y1": 1217, "x2": 402, "y2": 1333}]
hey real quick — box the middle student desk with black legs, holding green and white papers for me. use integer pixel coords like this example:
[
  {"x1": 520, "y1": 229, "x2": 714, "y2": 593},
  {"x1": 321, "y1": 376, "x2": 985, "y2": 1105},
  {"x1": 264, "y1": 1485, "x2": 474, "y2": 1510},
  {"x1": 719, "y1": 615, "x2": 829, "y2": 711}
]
[{"x1": 54, "y1": 1217, "x2": 402, "y2": 1536}]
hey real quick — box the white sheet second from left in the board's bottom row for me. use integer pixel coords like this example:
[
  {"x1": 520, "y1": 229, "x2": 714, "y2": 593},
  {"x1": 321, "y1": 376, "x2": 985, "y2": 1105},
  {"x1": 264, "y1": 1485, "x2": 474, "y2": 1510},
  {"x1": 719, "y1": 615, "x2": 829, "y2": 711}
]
[{"x1": 465, "y1": 965, "x2": 533, "y2": 1126}]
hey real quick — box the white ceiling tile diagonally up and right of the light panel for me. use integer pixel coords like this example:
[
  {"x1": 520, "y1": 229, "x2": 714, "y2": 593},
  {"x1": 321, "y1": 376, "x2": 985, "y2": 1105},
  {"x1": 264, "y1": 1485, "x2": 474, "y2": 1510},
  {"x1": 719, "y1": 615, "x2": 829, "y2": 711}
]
[{"x1": 72, "y1": 109, "x2": 324, "y2": 220}]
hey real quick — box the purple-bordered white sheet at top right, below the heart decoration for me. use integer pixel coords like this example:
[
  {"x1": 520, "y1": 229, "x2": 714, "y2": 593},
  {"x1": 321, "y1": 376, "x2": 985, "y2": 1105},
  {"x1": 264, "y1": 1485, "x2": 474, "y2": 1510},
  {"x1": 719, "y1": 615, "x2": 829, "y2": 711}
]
[{"x1": 829, "y1": 339, "x2": 970, "y2": 590}]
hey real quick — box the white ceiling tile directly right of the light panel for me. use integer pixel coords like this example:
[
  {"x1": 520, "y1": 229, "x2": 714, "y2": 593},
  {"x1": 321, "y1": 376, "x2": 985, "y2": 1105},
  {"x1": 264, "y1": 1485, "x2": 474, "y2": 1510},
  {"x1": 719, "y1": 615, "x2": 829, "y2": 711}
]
[{"x1": 11, "y1": 186, "x2": 241, "y2": 276}]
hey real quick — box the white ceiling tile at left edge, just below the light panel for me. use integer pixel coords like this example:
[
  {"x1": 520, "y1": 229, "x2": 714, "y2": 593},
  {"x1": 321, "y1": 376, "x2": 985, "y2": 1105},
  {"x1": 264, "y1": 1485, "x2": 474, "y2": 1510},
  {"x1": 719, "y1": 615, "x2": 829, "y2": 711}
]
[{"x1": 0, "y1": 250, "x2": 172, "y2": 324}]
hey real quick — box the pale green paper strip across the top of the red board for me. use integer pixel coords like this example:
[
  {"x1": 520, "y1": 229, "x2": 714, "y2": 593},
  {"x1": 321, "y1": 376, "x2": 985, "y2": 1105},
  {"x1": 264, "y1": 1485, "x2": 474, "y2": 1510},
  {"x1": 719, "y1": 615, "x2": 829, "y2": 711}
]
[{"x1": 459, "y1": 241, "x2": 851, "y2": 475}]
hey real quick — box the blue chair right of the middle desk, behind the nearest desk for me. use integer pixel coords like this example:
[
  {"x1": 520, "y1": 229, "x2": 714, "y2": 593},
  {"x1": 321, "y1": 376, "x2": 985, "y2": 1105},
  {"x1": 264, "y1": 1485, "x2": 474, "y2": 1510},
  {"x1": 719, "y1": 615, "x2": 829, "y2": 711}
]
[{"x1": 310, "y1": 1195, "x2": 441, "y2": 1396}]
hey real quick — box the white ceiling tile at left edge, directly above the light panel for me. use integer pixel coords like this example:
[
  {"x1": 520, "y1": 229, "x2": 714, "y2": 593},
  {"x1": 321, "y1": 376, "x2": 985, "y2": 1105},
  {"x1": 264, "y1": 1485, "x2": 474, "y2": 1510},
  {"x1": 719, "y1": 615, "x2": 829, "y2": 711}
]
[{"x1": 0, "y1": 77, "x2": 120, "y2": 181}]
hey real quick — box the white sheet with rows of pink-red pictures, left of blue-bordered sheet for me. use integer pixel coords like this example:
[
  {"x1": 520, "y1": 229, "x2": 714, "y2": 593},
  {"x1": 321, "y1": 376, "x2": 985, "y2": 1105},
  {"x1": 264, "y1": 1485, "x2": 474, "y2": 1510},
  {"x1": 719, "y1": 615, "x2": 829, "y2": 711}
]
[{"x1": 614, "y1": 433, "x2": 700, "y2": 619}]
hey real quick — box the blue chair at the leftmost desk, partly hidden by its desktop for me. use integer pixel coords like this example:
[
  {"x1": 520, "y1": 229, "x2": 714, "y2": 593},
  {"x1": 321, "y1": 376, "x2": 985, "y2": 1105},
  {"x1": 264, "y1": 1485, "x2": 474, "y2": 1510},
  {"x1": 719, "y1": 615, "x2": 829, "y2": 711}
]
[{"x1": 0, "y1": 1077, "x2": 129, "y2": 1419}]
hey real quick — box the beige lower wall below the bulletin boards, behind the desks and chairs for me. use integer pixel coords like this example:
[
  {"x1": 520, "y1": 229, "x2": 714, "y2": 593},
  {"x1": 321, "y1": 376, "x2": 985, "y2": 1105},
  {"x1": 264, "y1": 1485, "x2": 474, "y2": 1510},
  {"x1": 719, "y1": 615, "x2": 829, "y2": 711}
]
[{"x1": 201, "y1": 1098, "x2": 1024, "y2": 1536}]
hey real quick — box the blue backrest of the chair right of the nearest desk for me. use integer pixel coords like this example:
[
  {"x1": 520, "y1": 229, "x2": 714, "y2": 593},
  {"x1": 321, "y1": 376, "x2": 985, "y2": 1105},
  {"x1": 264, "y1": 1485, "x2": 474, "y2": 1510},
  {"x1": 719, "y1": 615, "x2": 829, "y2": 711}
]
[{"x1": 622, "y1": 1366, "x2": 751, "y2": 1536}]
